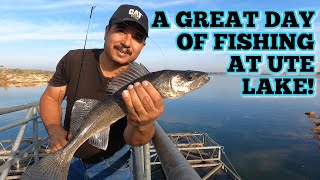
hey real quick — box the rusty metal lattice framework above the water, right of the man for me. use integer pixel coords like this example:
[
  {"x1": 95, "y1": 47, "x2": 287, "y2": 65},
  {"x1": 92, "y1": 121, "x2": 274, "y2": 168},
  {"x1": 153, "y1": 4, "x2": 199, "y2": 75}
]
[{"x1": 150, "y1": 132, "x2": 241, "y2": 180}]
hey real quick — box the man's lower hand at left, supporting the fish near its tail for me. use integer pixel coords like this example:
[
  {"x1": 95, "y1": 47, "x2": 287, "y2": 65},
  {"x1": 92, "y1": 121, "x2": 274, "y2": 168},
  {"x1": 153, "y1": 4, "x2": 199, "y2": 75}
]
[{"x1": 49, "y1": 127, "x2": 72, "y2": 153}]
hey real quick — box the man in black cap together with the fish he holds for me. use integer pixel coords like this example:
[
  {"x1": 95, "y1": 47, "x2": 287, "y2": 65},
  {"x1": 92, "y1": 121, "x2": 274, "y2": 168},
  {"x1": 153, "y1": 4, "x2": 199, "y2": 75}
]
[{"x1": 21, "y1": 5, "x2": 210, "y2": 180}]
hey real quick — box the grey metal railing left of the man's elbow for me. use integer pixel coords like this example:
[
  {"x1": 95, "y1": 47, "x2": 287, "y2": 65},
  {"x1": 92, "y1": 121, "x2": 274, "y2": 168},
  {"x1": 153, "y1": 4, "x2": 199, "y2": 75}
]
[{"x1": 0, "y1": 102, "x2": 43, "y2": 180}]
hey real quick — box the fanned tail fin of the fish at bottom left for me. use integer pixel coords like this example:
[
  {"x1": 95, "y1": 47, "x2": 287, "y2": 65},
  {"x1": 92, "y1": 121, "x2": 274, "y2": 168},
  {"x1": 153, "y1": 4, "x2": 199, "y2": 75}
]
[{"x1": 21, "y1": 150, "x2": 72, "y2": 180}]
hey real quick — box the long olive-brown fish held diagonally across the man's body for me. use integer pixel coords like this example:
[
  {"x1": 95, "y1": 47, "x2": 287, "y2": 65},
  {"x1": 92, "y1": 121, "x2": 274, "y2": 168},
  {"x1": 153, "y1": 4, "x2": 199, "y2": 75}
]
[{"x1": 21, "y1": 70, "x2": 210, "y2": 180}]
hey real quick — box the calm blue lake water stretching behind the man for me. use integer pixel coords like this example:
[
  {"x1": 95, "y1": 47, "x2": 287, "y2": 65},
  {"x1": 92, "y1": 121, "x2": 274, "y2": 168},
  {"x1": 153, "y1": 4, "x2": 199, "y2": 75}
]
[{"x1": 0, "y1": 76, "x2": 320, "y2": 180}]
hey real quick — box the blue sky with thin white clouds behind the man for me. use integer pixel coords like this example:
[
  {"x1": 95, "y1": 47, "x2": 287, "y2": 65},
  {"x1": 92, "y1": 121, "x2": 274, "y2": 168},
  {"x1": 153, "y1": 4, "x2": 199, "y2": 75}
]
[{"x1": 0, "y1": 0, "x2": 320, "y2": 71}]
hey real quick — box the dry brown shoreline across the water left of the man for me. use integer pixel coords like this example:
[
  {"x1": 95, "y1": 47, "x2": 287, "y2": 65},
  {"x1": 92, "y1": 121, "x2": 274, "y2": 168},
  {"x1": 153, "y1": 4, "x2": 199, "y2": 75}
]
[{"x1": 0, "y1": 67, "x2": 54, "y2": 87}]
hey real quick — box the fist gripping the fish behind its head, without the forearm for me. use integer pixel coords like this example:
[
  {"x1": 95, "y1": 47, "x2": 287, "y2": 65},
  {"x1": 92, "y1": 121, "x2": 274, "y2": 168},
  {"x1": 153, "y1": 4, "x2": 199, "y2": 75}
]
[{"x1": 122, "y1": 81, "x2": 164, "y2": 127}]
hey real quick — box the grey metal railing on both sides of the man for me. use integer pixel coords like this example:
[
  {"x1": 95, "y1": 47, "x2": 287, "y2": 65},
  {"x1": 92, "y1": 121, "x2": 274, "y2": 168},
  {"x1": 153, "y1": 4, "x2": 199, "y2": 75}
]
[{"x1": 0, "y1": 102, "x2": 200, "y2": 180}]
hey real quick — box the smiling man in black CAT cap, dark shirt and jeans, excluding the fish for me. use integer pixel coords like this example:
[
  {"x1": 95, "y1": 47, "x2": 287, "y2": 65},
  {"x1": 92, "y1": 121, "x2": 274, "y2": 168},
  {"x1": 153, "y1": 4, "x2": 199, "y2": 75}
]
[{"x1": 40, "y1": 5, "x2": 164, "y2": 179}]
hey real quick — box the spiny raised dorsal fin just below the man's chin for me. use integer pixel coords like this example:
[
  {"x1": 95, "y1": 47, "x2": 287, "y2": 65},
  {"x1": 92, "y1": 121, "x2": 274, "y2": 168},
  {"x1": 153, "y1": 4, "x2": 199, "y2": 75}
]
[{"x1": 107, "y1": 62, "x2": 150, "y2": 94}]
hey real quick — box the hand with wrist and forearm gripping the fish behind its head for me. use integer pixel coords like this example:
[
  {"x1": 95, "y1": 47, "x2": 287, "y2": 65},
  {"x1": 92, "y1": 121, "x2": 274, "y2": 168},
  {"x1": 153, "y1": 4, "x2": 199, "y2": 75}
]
[{"x1": 122, "y1": 81, "x2": 164, "y2": 146}]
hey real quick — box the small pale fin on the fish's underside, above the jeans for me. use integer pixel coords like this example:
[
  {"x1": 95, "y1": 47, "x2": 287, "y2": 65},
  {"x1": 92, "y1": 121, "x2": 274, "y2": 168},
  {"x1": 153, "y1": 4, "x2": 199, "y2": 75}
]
[{"x1": 89, "y1": 127, "x2": 110, "y2": 150}]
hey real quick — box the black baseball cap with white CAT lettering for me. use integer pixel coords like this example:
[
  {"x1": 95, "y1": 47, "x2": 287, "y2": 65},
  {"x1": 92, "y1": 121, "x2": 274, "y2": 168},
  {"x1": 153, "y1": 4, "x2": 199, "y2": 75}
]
[{"x1": 109, "y1": 4, "x2": 149, "y2": 37}]
